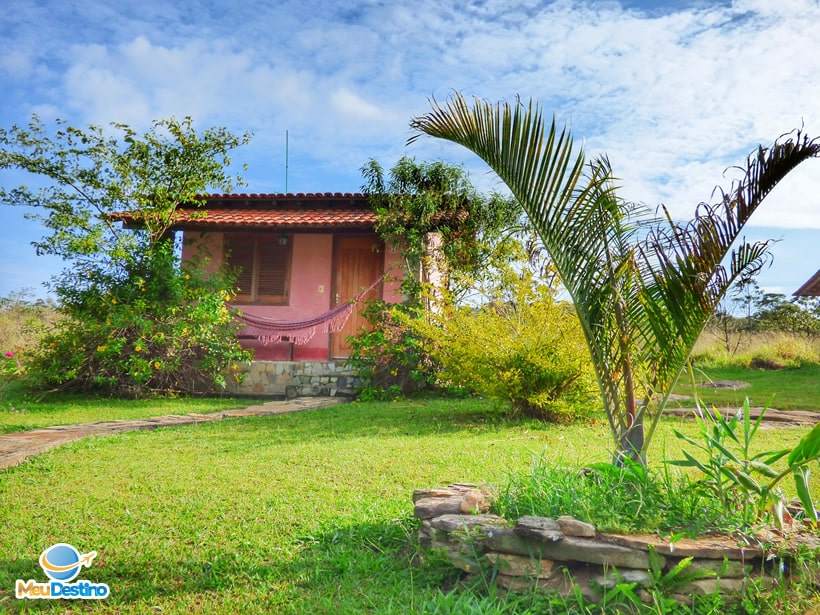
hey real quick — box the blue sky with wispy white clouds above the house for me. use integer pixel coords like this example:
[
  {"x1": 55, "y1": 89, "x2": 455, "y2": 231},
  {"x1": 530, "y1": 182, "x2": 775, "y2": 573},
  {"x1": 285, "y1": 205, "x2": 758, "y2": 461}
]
[{"x1": 0, "y1": 0, "x2": 820, "y2": 296}]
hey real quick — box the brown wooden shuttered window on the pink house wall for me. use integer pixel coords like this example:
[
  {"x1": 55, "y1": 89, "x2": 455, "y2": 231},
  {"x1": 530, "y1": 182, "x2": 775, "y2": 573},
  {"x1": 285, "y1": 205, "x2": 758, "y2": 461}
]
[{"x1": 225, "y1": 233, "x2": 293, "y2": 305}]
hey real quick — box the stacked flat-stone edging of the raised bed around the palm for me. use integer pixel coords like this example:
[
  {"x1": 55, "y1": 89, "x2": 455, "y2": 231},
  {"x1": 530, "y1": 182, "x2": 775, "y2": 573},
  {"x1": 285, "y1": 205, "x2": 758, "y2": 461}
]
[{"x1": 413, "y1": 484, "x2": 820, "y2": 604}]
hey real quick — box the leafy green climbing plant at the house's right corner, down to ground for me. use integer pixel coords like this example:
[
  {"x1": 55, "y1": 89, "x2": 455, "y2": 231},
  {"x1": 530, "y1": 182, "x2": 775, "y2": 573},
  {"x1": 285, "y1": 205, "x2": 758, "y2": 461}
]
[{"x1": 351, "y1": 156, "x2": 521, "y2": 398}]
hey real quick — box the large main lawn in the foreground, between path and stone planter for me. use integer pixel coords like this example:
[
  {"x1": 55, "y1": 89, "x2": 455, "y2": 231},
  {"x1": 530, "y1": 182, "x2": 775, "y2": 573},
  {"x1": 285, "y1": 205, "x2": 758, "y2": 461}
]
[{"x1": 0, "y1": 400, "x2": 820, "y2": 614}]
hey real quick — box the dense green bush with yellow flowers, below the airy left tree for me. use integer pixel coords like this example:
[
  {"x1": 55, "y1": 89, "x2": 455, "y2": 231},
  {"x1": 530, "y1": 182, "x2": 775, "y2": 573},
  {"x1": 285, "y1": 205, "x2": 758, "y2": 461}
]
[{"x1": 26, "y1": 244, "x2": 250, "y2": 397}]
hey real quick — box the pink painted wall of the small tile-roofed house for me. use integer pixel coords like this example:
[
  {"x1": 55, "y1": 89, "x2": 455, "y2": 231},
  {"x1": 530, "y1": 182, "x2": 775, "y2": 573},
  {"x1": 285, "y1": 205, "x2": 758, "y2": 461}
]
[{"x1": 182, "y1": 233, "x2": 403, "y2": 361}]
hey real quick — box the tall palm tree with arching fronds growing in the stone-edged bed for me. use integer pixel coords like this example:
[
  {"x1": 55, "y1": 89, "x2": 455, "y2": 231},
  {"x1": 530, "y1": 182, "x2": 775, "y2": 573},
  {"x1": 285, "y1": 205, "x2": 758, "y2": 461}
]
[{"x1": 410, "y1": 94, "x2": 820, "y2": 463}]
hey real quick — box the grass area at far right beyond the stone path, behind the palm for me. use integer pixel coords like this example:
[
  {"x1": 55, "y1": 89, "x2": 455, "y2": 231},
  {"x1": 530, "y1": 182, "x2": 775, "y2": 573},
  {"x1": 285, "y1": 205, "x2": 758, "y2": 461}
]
[{"x1": 674, "y1": 363, "x2": 820, "y2": 412}]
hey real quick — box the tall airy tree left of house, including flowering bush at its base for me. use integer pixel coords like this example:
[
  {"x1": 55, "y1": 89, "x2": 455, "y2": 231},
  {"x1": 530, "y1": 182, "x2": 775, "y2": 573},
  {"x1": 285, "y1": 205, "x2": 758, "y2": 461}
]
[{"x1": 0, "y1": 116, "x2": 250, "y2": 395}]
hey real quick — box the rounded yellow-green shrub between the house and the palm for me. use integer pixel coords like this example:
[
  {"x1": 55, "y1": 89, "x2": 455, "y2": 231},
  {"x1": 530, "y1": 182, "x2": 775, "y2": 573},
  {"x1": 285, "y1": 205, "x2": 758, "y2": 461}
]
[{"x1": 407, "y1": 270, "x2": 597, "y2": 421}]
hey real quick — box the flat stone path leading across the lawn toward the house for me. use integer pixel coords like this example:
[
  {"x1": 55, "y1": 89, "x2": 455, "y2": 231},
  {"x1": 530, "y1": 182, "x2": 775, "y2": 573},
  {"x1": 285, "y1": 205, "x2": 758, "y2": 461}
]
[{"x1": 0, "y1": 397, "x2": 345, "y2": 470}]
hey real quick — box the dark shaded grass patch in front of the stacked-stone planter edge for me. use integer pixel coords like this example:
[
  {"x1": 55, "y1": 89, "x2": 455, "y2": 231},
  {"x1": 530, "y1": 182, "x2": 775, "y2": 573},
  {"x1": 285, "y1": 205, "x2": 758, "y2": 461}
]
[{"x1": 274, "y1": 517, "x2": 575, "y2": 615}]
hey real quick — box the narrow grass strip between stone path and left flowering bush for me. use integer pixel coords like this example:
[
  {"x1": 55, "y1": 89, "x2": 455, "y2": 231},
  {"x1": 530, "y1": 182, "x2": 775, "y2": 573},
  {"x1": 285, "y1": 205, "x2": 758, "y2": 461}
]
[{"x1": 0, "y1": 379, "x2": 268, "y2": 434}]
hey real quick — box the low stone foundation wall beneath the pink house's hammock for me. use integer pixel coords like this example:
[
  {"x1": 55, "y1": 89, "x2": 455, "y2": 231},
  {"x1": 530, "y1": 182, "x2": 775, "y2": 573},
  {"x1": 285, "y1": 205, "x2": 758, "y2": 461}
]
[{"x1": 228, "y1": 361, "x2": 361, "y2": 399}]
